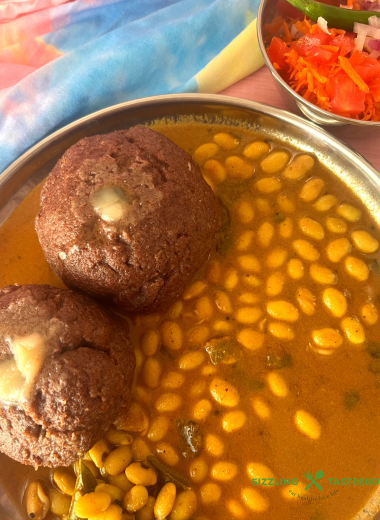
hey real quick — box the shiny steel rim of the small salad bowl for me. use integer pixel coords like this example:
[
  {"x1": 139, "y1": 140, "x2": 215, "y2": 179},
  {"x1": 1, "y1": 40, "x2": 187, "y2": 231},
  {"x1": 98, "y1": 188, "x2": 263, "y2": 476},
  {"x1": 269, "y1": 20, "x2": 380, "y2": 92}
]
[{"x1": 257, "y1": 0, "x2": 380, "y2": 130}]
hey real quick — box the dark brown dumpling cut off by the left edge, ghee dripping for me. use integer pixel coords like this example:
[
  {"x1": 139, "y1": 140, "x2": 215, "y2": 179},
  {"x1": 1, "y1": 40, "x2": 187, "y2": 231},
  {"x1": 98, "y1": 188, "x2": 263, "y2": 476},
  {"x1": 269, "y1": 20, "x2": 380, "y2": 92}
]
[{"x1": 0, "y1": 285, "x2": 135, "y2": 467}]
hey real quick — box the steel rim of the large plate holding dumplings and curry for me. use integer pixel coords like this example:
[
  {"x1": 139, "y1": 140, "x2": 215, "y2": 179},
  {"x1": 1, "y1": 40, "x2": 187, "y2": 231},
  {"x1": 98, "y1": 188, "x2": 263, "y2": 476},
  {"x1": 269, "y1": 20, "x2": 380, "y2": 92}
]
[{"x1": 0, "y1": 94, "x2": 380, "y2": 520}]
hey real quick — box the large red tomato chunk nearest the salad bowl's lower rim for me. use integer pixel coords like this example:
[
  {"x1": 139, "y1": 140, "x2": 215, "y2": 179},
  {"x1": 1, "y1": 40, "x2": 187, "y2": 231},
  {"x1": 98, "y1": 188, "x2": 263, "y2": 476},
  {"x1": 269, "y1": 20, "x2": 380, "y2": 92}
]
[{"x1": 330, "y1": 70, "x2": 365, "y2": 115}]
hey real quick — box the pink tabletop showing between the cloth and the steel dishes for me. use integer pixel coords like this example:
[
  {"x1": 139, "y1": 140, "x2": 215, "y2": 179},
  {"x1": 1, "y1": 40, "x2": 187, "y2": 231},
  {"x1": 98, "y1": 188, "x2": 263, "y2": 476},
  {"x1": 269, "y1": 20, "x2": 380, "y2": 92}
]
[{"x1": 220, "y1": 66, "x2": 380, "y2": 172}]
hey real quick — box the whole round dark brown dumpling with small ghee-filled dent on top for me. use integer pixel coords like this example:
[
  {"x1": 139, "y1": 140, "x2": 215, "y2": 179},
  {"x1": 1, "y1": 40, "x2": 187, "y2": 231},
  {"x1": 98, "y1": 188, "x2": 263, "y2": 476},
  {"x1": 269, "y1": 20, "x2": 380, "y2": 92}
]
[{"x1": 35, "y1": 126, "x2": 222, "y2": 312}]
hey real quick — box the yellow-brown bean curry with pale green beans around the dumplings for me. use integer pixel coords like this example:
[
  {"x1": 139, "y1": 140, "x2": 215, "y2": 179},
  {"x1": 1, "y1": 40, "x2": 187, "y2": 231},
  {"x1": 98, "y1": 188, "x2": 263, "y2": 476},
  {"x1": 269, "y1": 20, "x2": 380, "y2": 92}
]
[{"x1": 0, "y1": 124, "x2": 380, "y2": 520}]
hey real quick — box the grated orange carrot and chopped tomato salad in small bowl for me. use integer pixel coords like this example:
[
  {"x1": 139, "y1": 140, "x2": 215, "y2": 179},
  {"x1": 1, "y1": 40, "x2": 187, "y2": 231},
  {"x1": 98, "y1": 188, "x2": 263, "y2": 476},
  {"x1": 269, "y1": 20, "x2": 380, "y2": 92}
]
[{"x1": 265, "y1": 16, "x2": 380, "y2": 121}]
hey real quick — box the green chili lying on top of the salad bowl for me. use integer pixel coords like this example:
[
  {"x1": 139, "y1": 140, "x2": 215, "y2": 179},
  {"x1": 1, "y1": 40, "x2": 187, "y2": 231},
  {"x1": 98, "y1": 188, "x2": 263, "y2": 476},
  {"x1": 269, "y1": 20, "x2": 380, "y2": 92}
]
[{"x1": 287, "y1": 0, "x2": 380, "y2": 31}]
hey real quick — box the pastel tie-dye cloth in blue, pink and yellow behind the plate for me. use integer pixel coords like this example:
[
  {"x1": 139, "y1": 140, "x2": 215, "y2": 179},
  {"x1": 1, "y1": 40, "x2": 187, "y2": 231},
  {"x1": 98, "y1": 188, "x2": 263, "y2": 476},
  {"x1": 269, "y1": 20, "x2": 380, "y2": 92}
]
[{"x1": 0, "y1": 0, "x2": 263, "y2": 172}]
